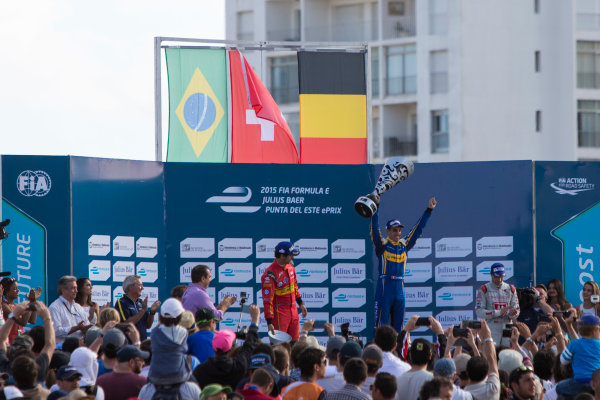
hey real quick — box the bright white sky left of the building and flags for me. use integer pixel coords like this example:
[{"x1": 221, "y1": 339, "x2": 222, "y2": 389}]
[{"x1": 0, "y1": 0, "x2": 225, "y2": 160}]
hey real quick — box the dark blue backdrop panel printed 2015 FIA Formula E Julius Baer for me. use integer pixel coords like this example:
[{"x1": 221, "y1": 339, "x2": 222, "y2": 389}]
[{"x1": 165, "y1": 163, "x2": 375, "y2": 337}]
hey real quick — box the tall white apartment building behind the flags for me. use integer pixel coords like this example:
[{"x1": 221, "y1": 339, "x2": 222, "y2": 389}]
[{"x1": 226, "y1": 0, "x2": 600, "y2": 162}]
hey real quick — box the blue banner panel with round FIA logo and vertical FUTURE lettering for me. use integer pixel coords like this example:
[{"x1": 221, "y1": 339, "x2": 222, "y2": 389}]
[{"x1": 2, "y1": 156, "x2": 71, "y2": 301}]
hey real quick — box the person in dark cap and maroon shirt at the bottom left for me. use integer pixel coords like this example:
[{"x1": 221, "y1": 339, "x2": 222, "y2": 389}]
[{"x1": 97, "y1": 345, "x2": 148, "y2": 400}]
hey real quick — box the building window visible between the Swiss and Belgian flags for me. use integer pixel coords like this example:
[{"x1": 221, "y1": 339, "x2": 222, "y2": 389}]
[{"x1": 269, "y1": 56, "x2": 298, "y2": 104}]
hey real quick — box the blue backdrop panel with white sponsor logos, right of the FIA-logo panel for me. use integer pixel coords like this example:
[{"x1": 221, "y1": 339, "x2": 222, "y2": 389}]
[{"x1": 71, "y1": 157, "x2": 170, "y2": 323}]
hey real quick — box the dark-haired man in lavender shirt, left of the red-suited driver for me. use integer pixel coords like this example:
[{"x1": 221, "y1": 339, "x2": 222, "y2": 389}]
[{"x1": 181, "y1": 264, "x2": 237, "y2": 320}]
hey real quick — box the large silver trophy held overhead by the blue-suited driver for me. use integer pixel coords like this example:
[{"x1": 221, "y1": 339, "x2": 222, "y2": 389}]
[{"x1": 354, "y1": 157, "x2": 415, "y2": 218}]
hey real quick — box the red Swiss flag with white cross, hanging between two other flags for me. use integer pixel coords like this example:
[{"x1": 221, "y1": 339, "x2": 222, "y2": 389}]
[{"x1": 229, "y1": 50, "x2": 298, "y2": 164}]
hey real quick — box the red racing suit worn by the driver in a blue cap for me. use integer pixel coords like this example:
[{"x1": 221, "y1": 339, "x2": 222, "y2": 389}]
[{"x1": 261, "y1": 261, "x2": 302, "y2": 340}]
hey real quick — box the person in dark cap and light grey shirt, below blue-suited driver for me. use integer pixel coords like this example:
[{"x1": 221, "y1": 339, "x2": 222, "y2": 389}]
[{"x1": 396, "y1": 339, "x2": 433, "y2": 400}]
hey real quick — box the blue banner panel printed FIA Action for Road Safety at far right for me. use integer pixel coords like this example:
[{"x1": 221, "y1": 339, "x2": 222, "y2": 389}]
[{"x1": 535, "y1": 161, "x2": 600, "y2": 304}]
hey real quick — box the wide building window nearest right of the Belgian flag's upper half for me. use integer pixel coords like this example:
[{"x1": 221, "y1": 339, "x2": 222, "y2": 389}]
[{"x1": 385, "y1": 45, "x2": 417, "y2": 96}]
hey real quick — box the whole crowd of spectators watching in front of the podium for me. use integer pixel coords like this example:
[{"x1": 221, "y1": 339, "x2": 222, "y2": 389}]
[{"x1": 0, "y1": 268, "x2": 600, "y2": 400}]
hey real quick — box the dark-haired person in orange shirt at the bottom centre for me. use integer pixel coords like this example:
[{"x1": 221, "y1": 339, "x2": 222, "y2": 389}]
[{"x1": 281, "y1": 347, "x2": 327, "y2": 400}]
